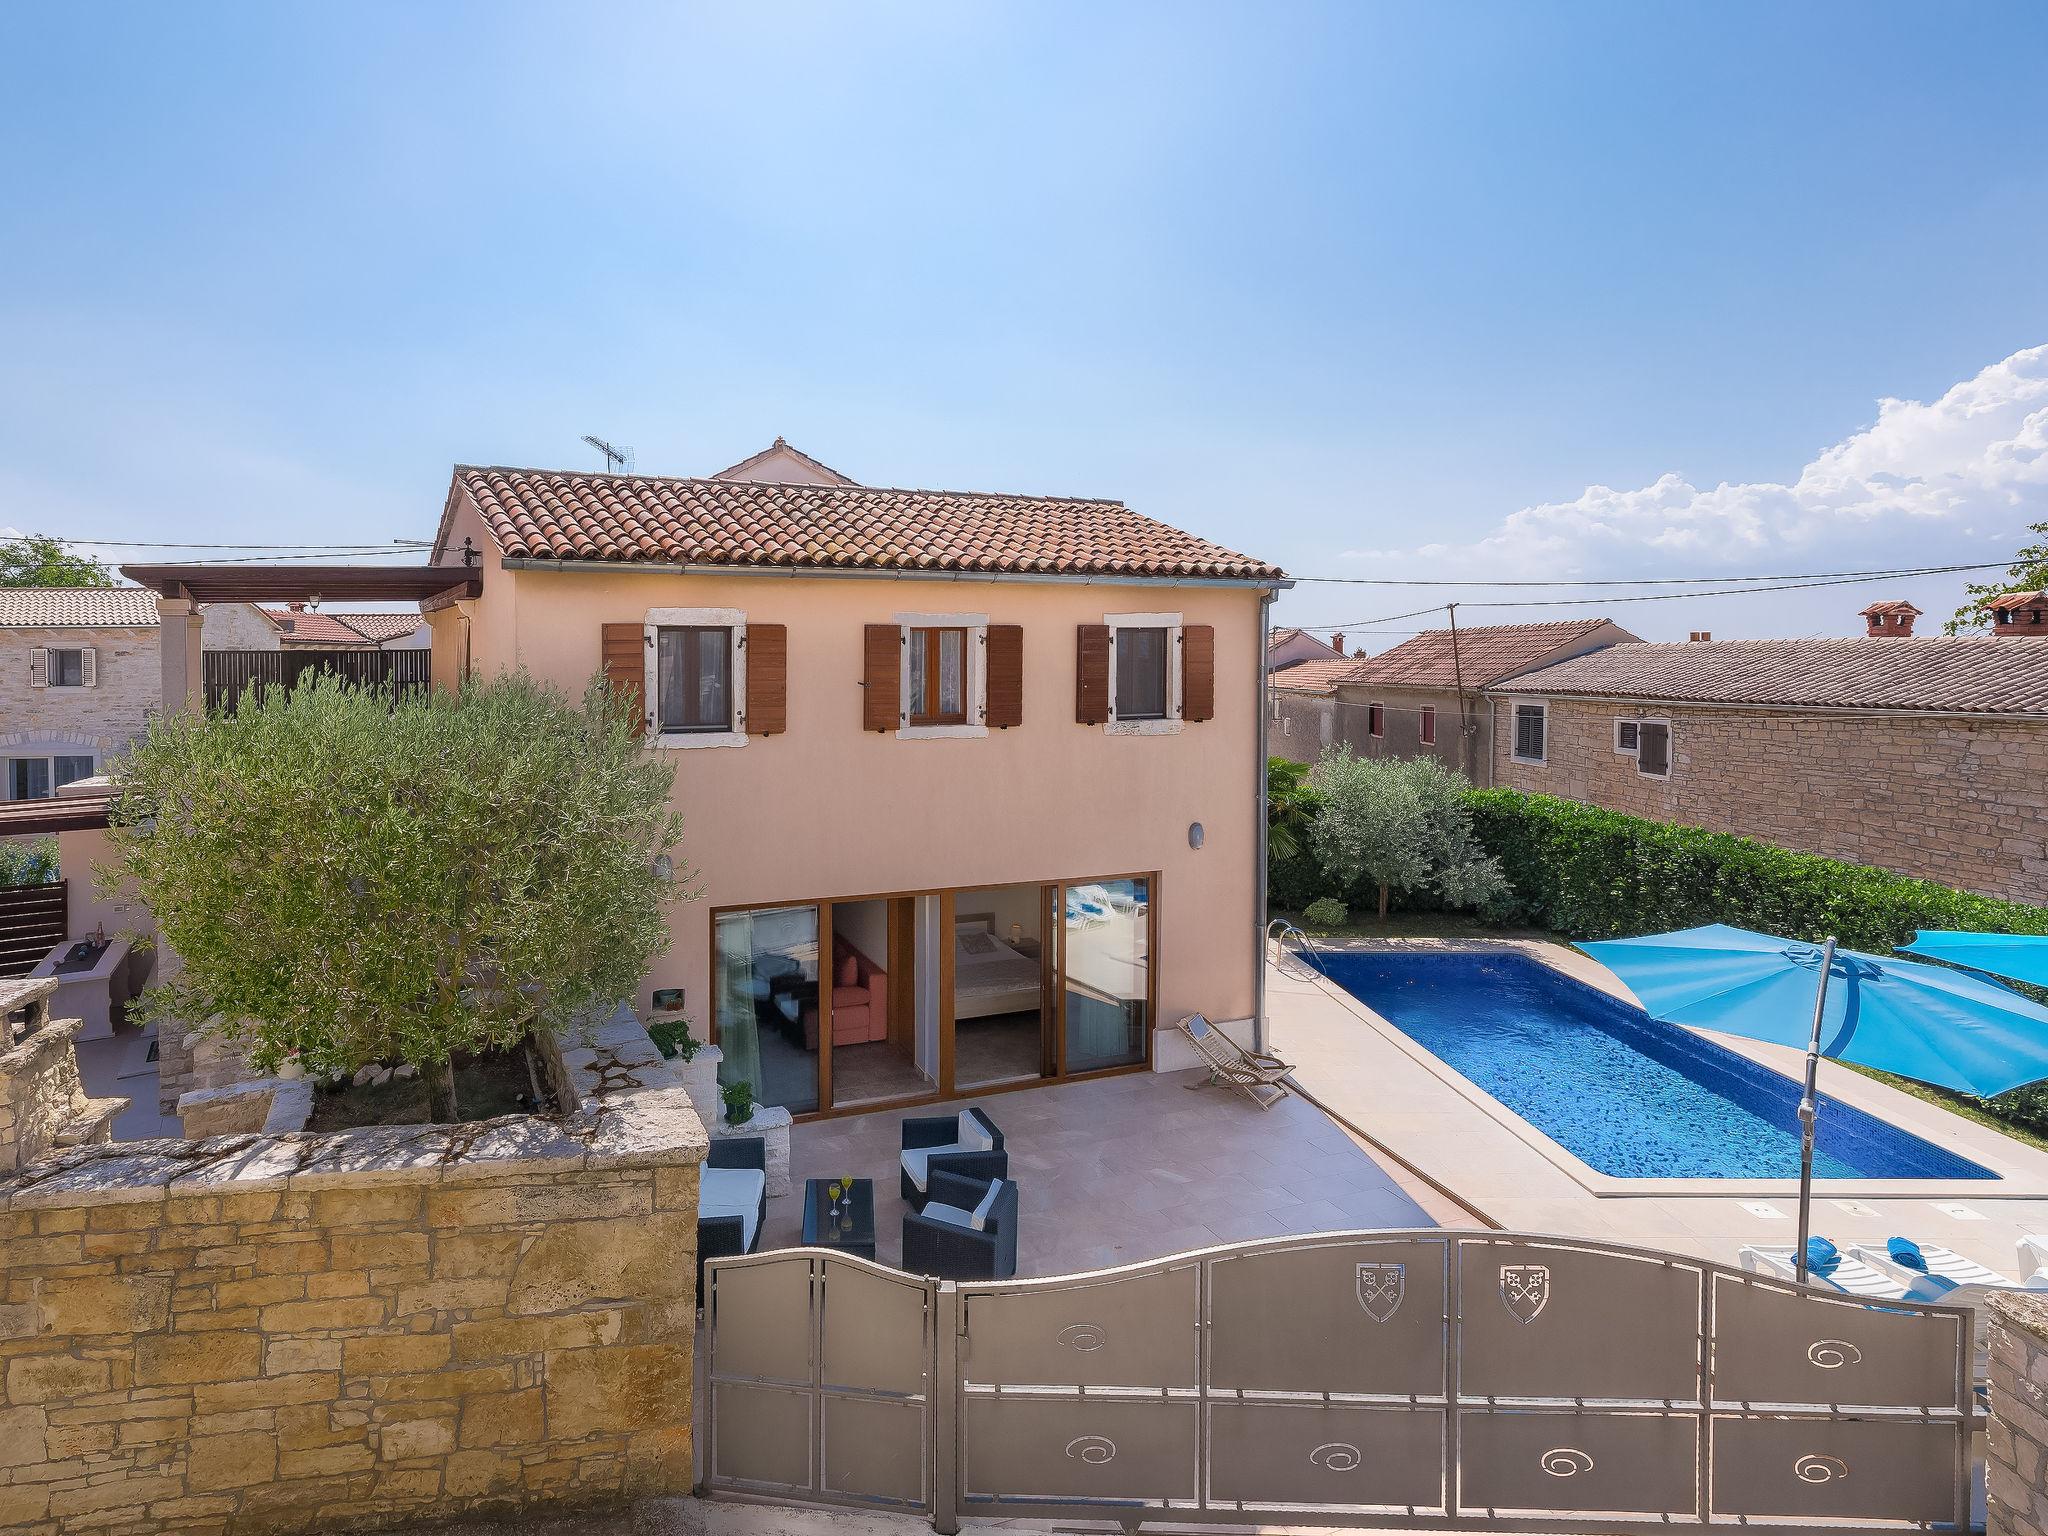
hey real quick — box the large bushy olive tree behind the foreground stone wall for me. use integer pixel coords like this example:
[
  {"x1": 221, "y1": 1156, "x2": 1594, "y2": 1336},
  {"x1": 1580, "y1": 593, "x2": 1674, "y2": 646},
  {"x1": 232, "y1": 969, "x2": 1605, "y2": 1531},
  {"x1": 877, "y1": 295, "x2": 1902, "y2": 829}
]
[{"x1": 100, "y1": 676, "x2": 682, "y2": 1120}]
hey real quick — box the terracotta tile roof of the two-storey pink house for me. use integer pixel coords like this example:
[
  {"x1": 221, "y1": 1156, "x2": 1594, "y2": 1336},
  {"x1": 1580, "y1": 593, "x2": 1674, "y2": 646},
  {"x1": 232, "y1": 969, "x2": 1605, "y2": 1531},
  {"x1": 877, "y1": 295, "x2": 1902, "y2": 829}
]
[{"x1": 442, "y1": 465, "x2": 1282, "y2": 582}]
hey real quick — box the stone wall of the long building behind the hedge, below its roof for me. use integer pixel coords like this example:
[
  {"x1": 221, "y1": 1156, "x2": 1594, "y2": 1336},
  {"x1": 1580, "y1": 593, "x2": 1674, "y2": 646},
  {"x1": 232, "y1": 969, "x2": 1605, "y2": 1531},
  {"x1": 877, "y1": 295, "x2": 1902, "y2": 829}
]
[{"x1": 1493, "y1": 696, "x2": 2048, "y2": 903}]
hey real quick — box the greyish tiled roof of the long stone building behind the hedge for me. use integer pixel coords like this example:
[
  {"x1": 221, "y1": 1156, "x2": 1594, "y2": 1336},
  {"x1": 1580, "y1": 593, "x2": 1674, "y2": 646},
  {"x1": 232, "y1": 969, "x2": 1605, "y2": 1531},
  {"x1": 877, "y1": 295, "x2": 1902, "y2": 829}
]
[{"x1": 1499, "y1": 635, "x2": 2048, "y2": 715}]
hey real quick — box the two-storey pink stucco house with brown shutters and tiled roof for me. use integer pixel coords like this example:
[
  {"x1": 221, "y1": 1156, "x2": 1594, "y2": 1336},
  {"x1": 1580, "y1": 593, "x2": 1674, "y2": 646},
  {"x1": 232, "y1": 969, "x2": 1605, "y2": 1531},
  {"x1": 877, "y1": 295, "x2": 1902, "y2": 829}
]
[{"x1": 424, "y1": 438, "x2": 1286, "y2": 1114}]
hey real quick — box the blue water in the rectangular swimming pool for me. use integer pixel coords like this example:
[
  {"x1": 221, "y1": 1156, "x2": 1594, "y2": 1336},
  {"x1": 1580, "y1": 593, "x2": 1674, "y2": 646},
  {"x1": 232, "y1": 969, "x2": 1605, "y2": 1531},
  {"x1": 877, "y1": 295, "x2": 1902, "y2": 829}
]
[{"x1": 1319, "y1": 950, "x2": 1997, "y2": 1180}]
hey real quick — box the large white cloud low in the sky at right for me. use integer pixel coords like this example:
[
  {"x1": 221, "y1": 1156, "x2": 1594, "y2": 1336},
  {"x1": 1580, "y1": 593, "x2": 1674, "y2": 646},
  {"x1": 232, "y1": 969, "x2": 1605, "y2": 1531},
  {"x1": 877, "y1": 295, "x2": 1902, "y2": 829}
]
[{"x1": 1350, "y1": 346, "x2": 2048, "y2": 578}]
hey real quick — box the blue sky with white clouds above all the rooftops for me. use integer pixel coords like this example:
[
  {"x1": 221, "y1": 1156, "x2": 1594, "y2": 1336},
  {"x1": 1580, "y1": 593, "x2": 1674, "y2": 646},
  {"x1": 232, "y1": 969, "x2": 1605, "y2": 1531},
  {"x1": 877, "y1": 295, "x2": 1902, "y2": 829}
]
[{"x1": 0, "y1": 4, "x2": 2048, "y2": 647}]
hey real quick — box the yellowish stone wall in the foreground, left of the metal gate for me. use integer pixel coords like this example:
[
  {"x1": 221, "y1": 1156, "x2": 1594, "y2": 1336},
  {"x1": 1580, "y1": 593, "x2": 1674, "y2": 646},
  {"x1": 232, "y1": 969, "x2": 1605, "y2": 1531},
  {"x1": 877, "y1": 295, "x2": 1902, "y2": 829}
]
[{"x1": 0, "y1": 1015, "x2": 707, "y2": 1536}]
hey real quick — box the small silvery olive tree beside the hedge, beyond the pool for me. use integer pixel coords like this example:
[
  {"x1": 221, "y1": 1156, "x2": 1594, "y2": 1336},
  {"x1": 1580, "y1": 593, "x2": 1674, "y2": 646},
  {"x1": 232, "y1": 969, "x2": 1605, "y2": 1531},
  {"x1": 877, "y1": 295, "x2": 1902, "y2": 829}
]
[{"x1": 1309, "y1": 748, "x2": 1507, "y2": 918}]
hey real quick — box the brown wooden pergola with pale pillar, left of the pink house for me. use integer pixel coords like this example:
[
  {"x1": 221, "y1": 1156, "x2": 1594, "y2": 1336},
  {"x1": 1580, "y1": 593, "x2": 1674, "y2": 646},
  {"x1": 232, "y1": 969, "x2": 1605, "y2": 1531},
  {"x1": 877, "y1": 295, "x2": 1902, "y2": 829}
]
[{"x1": 121, "y1": 561, "x2": 483, "y2": 709}]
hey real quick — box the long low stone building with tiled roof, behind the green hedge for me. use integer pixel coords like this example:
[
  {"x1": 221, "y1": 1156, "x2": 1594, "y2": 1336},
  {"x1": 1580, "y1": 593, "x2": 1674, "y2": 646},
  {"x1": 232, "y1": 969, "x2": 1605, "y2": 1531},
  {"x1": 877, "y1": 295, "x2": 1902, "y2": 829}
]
[{"x1": 1487, "y1": 631, "x2": 2048, "y2": 903}]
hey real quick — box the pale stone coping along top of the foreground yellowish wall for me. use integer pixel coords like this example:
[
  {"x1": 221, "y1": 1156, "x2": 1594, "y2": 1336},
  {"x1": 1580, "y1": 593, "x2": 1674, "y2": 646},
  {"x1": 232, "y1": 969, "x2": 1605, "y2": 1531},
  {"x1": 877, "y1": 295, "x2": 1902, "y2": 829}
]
[{"x1": 0, "y1": 1085, "x2": 711, "y2": 1210}]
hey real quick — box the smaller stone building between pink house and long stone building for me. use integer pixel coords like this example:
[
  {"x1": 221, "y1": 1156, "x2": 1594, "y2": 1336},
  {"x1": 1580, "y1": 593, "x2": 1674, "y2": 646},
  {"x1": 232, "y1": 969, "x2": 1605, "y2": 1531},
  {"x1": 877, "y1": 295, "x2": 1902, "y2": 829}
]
[{"x1": 1331, "y1": 618, "x2": 1636, "y2": 784}]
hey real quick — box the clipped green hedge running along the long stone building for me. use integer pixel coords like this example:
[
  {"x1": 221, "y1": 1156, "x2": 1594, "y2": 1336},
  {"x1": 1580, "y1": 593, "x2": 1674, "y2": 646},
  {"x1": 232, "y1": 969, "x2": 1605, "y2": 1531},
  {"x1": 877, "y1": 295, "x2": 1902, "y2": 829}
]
[{"x1": 1468, "y1": 788, "x2": 2048, "y2": 954}]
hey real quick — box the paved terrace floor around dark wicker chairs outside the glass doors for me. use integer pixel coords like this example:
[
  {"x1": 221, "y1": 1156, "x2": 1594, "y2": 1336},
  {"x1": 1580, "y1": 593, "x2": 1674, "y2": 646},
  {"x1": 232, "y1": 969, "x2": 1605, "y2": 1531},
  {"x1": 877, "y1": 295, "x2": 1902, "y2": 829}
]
[{"x1": 762, "y1": 1071, "x2": 1470, "y2": 1276}]
